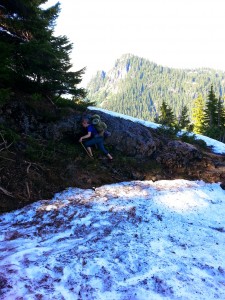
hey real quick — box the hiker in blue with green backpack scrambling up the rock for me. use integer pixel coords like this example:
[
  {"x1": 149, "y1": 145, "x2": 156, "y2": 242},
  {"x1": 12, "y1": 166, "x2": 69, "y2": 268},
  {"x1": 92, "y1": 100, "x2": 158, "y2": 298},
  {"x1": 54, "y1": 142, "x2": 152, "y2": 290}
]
[{"x1": 79, "y1": 118, "x2": 113, "y2": 160}]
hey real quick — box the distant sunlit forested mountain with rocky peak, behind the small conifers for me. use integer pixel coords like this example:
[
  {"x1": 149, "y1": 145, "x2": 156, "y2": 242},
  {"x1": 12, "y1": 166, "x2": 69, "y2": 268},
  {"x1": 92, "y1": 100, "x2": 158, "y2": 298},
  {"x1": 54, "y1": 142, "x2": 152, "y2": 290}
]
[{"x1": 87, "y1": 54, "x2": 225, "y2": 121}]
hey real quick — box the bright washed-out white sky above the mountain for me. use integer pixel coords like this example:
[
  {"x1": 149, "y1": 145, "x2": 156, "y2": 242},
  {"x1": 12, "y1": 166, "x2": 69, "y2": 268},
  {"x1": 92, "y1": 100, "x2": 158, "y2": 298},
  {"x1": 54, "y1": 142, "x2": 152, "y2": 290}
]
[{"x1": 45, "y1": 0, "x2": 225, "y2": 82}]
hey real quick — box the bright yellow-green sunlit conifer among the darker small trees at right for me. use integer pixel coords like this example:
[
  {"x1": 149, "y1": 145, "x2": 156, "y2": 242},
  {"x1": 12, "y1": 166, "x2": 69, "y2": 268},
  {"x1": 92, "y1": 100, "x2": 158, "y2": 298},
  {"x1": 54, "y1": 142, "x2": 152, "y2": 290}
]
[{"x1": 192, "y1": 95, "x2": 204, "y2": 134}]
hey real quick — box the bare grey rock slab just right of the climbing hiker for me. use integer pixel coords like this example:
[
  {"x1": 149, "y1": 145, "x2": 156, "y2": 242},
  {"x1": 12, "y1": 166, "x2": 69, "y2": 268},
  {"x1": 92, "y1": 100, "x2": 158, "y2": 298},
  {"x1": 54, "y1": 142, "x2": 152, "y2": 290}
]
[{"x1": 85, "y1": 111, "x2": 203, "y2": 169}]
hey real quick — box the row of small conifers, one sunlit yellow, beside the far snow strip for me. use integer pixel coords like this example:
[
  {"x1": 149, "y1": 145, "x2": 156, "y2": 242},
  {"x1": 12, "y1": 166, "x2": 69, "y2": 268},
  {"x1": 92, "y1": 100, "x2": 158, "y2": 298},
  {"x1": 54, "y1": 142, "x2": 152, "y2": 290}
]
[{"x1": 155, "y1": 86, "x2": 225, "y2": 147}]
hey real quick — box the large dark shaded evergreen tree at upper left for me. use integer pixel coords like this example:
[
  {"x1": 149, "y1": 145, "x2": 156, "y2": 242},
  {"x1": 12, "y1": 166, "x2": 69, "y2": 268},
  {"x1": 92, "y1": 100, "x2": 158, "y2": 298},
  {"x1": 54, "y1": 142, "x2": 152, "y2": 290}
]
[{"x1": 0, "y1": 0, "x2": 86, "y2": 98}]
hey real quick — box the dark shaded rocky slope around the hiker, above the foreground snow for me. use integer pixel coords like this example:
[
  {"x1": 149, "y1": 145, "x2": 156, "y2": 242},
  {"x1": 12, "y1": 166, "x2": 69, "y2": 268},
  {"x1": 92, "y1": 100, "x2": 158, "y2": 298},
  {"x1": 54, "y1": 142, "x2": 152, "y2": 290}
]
[{"x1": 0, "y1": 102, "x2": 225, "y2": 212}]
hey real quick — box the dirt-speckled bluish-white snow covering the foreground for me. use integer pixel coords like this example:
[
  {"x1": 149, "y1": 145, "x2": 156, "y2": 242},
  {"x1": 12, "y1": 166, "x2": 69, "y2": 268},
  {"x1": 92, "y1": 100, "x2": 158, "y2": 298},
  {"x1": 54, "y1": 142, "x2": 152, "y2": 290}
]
[{"x1": 0, "y1": 108, "x2": 225, "y2": 300}]
